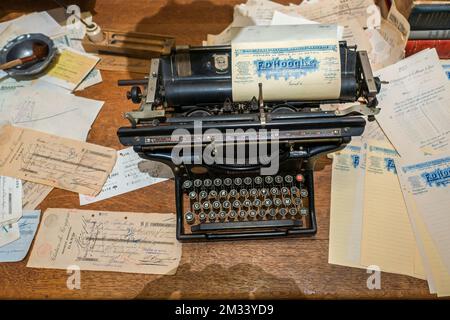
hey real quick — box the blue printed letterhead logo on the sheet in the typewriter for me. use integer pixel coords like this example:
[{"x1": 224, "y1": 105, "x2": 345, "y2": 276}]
[{"x1": 254, "y1": 57, "x2": 320, "y2": 80}]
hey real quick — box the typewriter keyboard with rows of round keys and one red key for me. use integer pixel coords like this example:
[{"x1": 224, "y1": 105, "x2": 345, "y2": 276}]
[{"x1": 182, "y1": 174, "x2": 309, "y2": 232}]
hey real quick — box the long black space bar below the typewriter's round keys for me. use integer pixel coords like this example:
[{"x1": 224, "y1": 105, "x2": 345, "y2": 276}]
[{"x1": 191, "y1": 219, "x2": 302, "y2": 232}]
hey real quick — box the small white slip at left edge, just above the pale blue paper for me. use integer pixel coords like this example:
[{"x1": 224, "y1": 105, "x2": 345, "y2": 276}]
[{"x1": 0, "y1": 176, "x2": 22, "y2": 226}]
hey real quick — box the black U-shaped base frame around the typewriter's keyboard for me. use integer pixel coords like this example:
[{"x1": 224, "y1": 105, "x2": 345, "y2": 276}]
[{"x1": 175, "y1": 169, "x2": 317, "y2": 241}]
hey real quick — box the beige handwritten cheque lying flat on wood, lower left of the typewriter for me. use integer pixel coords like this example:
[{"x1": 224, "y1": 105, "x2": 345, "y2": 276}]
[{"x1": 27, "y1": 209, "x2": 181, "y2": 274}]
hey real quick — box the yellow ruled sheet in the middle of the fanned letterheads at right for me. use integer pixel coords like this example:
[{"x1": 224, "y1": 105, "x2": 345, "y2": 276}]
[{"x1": 361, "y1": 141, "x2": 424, "y2": 277}]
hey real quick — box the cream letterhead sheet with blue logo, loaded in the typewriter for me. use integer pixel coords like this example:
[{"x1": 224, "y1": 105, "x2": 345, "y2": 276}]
[{"x1": 231, "y1": 24, "x2": 341, "y2": 101}]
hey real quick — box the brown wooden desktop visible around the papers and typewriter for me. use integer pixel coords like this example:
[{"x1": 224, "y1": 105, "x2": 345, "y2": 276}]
[{"x1": 0, "y1": 0, "x2": 433, "y2": 299}]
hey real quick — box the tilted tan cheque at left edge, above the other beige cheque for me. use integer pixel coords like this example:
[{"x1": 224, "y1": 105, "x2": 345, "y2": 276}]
[{"x1": 0, "y1": 125, "x2": 116, "y2": 196}]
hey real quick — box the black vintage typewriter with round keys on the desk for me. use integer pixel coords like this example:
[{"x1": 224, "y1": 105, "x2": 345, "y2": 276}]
[{"x1": 118, "y1": 37, "x2": 380, "y2": 240}]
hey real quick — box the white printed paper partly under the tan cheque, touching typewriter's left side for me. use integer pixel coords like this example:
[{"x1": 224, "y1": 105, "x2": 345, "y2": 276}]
[{"x1": 80, "y1": 147, "x2": 167, "y2": 205}]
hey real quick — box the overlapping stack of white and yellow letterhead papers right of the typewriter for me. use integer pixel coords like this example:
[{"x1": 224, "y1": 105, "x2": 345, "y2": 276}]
[{"x1": 329, "y1": 49, "x2": 450, "y2": 296}]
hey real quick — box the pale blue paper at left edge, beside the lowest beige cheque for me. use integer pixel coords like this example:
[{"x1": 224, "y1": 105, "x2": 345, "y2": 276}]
[{"x1": 0, "y1": 210, "x2": 41, "y2": 262}]
